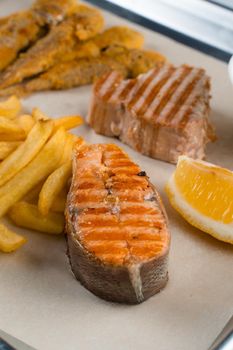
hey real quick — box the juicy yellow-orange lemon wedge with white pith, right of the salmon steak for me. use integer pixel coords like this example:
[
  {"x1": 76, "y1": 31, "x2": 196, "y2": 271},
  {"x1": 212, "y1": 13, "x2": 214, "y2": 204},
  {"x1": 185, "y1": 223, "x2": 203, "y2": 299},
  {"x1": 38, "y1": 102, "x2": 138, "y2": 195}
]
[{"x1": 166, "y1": 156, "x2": 233, "y2": 244}]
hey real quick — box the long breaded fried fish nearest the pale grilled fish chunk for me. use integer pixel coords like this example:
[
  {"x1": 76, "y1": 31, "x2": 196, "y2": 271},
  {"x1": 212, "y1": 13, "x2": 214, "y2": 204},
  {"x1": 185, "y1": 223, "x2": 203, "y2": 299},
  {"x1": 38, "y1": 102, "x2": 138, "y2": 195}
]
[{"x1": 0, "y1": 47, "x2": 165, "y2": 96}]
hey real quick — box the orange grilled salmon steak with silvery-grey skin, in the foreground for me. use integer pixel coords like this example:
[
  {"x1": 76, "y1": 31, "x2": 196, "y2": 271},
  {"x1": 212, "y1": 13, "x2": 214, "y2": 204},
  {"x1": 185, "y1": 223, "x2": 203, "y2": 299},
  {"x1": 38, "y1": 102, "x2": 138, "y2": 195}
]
[{"x1": 66, "y1": 144, "x2": 170, "y2": 304}]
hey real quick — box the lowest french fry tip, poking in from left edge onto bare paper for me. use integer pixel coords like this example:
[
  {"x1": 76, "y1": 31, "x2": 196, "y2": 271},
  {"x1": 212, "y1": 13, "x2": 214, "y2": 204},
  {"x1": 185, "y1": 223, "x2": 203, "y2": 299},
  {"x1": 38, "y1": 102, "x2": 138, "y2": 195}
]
[{"x1": 0, "y1": 223, "x2": 26, "y2": 253}]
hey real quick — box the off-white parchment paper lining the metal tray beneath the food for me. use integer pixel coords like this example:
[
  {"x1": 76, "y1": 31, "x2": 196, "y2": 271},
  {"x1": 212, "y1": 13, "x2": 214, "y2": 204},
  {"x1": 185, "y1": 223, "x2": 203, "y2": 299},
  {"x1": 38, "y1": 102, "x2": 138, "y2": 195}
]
[{"x1": 0, "y1": 0, "x2": 233, "y2": 350}]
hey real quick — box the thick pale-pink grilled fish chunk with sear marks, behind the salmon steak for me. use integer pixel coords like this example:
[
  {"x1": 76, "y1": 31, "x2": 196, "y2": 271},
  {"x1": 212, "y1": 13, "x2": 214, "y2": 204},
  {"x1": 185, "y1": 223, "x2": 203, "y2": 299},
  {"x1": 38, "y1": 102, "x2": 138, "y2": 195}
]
[{"x1": 88, "y1": 64, "x2": 215, "y2": 163}]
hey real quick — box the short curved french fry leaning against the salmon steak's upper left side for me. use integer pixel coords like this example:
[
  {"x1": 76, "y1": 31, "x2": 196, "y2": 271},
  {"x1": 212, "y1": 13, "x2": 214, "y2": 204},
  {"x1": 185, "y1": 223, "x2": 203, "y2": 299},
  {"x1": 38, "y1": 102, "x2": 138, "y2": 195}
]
[{"x1": 38, "y1": 161, "x2": 72, "y2": 215}]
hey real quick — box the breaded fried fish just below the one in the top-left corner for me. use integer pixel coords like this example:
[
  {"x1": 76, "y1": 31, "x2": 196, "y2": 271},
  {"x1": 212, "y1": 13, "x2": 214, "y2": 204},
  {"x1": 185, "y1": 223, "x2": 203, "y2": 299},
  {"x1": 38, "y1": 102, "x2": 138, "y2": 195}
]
[{"x1": 0, "y1": 5, "x2": 104, "y2": 89}]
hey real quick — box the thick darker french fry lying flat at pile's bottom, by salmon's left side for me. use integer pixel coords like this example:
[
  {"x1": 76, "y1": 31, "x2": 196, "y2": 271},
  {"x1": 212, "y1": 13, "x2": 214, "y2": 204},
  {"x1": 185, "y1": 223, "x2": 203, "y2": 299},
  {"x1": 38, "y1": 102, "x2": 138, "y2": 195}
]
[{"x1": 9, "y1": 202, "x2": 65, "y2": 234}]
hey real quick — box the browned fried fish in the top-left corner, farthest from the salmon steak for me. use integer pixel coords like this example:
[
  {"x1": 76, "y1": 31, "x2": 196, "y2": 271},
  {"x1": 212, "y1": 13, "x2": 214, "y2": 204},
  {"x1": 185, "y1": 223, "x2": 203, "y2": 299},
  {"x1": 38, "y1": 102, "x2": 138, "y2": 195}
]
[{"x1": 0, "y1": 0, "x2": 77, "y2": 71}]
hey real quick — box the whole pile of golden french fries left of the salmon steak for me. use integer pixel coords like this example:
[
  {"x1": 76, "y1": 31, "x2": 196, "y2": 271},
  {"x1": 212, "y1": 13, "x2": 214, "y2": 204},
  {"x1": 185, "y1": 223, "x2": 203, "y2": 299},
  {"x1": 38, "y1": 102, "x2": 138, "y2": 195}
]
[{"x1": 0, "y1": 96, "x2": 85, "y2": 252}]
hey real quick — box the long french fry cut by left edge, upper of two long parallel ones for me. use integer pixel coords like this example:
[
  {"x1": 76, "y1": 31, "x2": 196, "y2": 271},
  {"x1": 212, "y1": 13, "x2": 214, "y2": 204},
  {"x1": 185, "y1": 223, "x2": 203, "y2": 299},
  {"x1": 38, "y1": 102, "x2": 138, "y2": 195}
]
[{"x1": 0, "y1": 121, "x2": 53, "y2": 186}]
